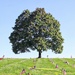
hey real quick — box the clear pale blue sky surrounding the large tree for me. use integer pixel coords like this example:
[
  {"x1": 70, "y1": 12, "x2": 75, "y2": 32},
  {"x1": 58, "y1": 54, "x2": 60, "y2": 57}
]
[{"x1": 0, "y1": 0, "x2": 75, "y2": 58}]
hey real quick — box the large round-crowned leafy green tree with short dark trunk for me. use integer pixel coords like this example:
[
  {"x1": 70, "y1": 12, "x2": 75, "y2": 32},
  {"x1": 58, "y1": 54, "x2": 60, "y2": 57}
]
[{"x1": 9, "y1": 8, "x2": 64, "y2": 58}]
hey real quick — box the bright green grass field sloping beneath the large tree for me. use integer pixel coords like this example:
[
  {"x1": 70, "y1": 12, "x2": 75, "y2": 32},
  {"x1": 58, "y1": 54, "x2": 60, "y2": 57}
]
[{"x1": 0, "y1": 58, "x2": 75, "y2": 75}]
